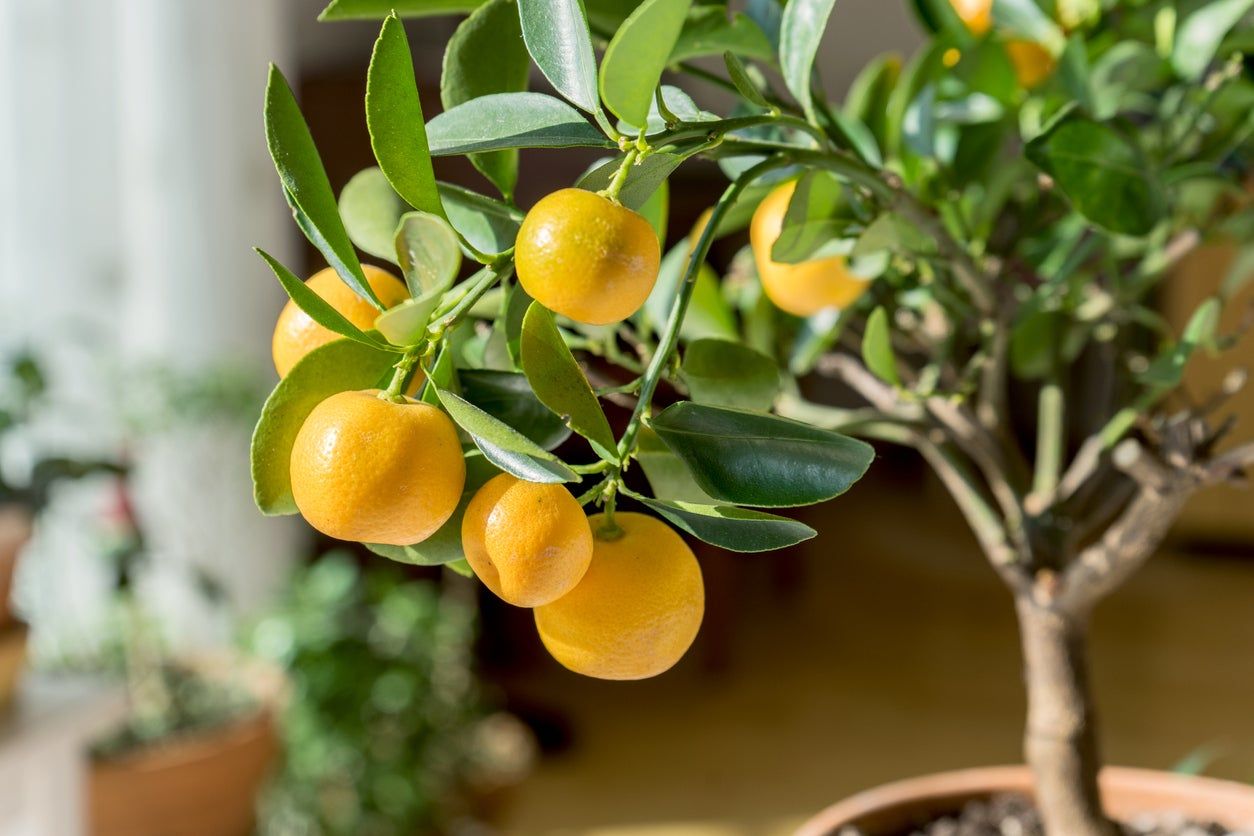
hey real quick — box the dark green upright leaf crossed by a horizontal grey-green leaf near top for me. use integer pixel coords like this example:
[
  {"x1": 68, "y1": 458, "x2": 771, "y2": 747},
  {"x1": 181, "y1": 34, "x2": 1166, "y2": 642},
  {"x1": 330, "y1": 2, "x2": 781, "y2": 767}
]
[{"x1": 441, "y1": 0, "x2": 532, "y2": 201}]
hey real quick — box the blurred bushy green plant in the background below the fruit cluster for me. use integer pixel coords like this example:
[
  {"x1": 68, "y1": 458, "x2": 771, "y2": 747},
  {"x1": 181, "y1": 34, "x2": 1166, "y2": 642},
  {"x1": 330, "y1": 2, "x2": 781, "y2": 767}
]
[{"x1": 252, "y1": 554, "x2": 534, "y2": 836}]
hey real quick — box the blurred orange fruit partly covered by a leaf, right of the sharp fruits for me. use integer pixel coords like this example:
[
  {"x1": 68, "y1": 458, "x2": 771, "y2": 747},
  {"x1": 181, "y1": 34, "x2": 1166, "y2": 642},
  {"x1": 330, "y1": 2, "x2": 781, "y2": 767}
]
[{"x1": 749, "y1": 180, "x2": 869, "y2": 316}]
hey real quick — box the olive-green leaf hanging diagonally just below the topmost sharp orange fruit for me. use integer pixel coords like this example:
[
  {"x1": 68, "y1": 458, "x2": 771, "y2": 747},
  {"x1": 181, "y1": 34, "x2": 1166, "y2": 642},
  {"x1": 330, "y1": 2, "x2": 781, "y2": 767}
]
[{"x1": 519, "y1": 302, "x2": 618, "y2": 462}]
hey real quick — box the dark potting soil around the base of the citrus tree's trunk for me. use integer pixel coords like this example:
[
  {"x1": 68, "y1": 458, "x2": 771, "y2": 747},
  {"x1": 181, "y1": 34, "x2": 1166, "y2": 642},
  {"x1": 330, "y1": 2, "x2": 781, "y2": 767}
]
[{"x1": 836, "y1": 795, "x2": 1254, "y2": 836}]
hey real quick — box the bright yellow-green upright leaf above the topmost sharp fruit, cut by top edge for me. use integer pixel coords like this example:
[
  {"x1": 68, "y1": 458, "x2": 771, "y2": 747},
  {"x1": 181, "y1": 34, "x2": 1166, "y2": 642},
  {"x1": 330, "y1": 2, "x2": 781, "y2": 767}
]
[{"x1": 601, "y1": 0, "x2": 691, "y2": 127}]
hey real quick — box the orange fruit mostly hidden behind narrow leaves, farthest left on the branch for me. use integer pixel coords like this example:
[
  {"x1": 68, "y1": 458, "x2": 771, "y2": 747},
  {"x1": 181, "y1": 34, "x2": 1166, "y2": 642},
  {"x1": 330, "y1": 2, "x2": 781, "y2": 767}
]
[{"x1": 271, "y1": 264, "x2": 409, "y2": 377}]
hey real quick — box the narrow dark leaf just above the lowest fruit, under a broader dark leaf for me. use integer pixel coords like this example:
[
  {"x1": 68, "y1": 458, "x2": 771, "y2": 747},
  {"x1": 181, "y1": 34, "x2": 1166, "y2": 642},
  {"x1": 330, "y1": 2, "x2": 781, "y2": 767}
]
[{"x1": 635, "y1": 496, "x2": 816, "y2": 551}]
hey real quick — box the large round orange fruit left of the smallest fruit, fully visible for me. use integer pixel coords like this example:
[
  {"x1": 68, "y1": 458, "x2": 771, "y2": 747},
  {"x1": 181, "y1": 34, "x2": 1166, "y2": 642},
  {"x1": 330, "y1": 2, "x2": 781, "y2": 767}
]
[{"x1": 291, "y1": 390, "x2": 466, "y2": 545}]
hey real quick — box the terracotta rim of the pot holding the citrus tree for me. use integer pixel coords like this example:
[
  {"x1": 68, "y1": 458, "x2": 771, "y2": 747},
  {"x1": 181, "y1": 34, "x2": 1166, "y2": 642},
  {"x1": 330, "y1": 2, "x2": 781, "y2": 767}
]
[{"x1": 796, "y1": 766, "x2": 1254, "y2": 836}]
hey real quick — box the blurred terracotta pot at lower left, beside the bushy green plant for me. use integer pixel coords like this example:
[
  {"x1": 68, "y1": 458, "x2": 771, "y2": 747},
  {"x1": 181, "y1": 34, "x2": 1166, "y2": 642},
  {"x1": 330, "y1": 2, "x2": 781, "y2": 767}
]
[{"x1": 89, "y1": 711, "x2": 278, "y2": 836}]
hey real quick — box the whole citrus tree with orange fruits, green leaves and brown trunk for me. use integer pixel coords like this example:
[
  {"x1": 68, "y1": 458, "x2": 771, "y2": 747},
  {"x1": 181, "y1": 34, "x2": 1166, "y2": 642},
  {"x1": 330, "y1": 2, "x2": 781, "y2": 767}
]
[{"x1": 253, "y1": 0, "x2": 1254, "y2": 836}]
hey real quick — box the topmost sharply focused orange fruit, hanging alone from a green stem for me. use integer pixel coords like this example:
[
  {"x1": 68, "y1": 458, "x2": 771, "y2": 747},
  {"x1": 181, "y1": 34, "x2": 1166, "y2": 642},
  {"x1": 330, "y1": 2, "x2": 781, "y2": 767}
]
[{"x1": 514, "y1": 188, "x2": 662, "y2": 325}]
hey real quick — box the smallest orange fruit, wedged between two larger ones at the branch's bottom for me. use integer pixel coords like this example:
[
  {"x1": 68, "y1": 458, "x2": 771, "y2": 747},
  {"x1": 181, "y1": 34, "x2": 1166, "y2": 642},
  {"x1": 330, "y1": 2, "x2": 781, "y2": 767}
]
[{"x1": 461, "y1": 474, "x2": 592, "y2": 607}]
